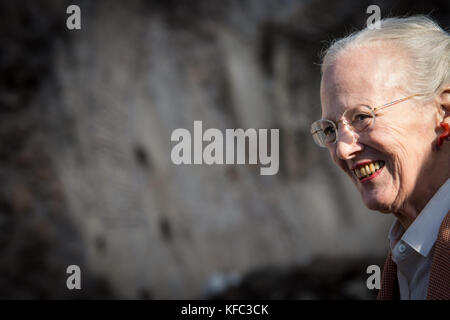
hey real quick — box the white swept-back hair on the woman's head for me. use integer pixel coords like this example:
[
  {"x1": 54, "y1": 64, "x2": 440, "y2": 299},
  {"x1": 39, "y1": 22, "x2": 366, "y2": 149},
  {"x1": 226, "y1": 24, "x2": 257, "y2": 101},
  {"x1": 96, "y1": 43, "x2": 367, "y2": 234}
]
[{"x1": 322, "y1": 15, "x2": 450, "y2": 97}]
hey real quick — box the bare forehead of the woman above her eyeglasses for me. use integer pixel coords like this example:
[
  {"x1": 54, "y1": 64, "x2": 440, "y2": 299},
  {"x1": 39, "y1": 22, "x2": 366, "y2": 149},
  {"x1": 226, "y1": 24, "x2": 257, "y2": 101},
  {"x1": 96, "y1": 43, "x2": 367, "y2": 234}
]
[{"x1": 320, "y1": 43, "x2": 408, "y2": 119}]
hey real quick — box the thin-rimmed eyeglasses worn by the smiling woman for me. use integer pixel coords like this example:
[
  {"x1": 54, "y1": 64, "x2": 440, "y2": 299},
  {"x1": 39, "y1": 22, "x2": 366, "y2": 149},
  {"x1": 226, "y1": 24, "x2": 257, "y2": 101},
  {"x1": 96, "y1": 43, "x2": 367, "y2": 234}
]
[{"x1": 311, "y1": 94, "x2": 418, "y2": 148}]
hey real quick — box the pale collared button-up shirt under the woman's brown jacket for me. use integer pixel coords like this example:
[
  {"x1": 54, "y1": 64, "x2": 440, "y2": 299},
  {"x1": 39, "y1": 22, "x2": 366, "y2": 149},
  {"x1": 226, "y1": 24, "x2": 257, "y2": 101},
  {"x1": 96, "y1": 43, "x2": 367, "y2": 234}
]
[{"x1": 389, "y1": 179, "x2": 450, "y2": 300}]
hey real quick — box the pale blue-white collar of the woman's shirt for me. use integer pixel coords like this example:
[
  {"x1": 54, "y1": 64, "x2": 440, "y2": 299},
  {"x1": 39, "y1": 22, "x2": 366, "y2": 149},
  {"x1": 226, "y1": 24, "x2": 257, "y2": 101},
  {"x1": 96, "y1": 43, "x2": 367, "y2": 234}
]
[{"x1": 389, "y1": 179, "x2": 450, "y2": 257}]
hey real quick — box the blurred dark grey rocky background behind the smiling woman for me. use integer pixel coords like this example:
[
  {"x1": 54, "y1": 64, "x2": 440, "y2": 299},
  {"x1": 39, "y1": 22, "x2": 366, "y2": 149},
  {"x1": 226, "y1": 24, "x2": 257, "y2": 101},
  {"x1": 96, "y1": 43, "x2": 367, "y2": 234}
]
[{"x1": 0, "y1": 0, "x2": 450, "y2": 299}]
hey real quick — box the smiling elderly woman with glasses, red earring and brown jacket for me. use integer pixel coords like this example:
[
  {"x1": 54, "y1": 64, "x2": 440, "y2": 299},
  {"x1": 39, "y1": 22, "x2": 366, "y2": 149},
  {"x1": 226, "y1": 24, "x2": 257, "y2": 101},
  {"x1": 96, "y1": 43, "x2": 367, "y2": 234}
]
[{"x1": 311, "y1": 16, "x2": 450, "y2": 299}]
